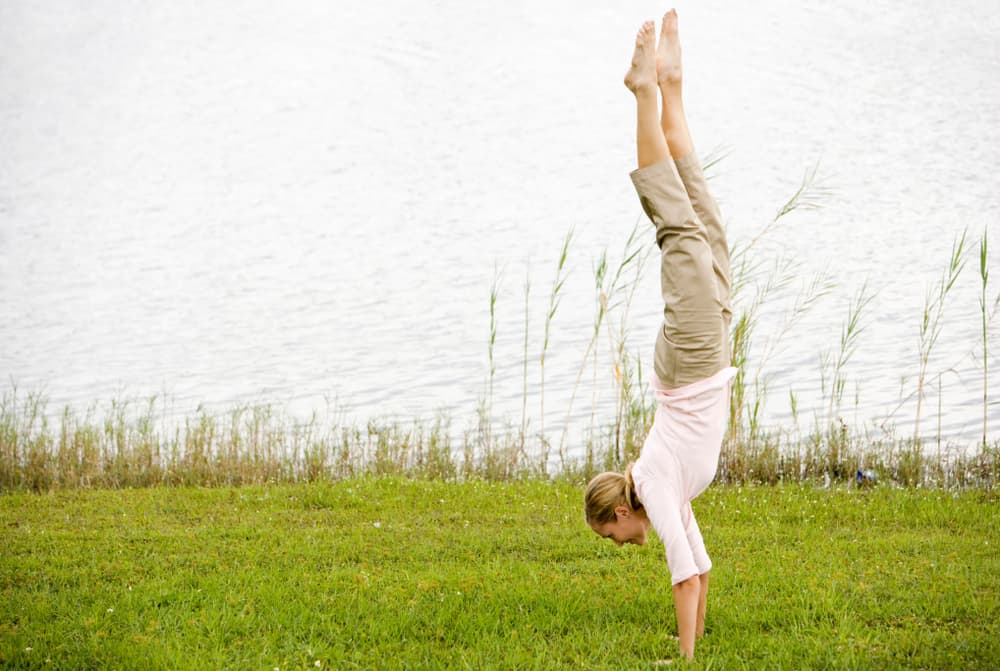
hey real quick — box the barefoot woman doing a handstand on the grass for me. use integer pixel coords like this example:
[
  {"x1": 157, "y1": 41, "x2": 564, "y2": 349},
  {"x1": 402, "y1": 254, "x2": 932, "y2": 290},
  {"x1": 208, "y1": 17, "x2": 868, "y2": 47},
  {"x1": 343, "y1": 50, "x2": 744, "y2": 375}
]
[{"x1": 585, "y1": 10, "x2": 736, "y2": 658}]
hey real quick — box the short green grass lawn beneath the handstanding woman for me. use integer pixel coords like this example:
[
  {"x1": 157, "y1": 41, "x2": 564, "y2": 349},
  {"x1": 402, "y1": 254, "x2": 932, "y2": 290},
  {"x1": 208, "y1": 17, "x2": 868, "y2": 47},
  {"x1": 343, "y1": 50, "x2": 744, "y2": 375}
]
[{"x1": 0, "y1": 478, "x2": 1000, "y2": 669}]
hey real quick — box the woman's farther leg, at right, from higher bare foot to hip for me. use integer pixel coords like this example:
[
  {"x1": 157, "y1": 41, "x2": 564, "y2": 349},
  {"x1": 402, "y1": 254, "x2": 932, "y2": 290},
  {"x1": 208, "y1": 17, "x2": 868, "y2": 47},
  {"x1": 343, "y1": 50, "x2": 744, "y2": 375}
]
[{"x1": 656, "y1": 9, "x2": 732, "y2": 336}]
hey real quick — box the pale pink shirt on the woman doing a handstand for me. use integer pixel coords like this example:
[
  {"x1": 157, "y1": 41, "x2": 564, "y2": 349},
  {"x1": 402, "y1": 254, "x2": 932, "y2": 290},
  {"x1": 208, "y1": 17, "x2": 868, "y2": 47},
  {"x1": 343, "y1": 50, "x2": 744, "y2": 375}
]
[{"x1": 632, "y1": 367, "x2": 736, "y2": 585}]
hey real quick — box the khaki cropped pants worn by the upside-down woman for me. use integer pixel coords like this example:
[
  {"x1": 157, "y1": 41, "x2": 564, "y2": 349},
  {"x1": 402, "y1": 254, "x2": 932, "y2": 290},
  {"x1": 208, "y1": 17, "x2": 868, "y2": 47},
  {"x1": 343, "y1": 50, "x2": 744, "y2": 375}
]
[{"x1": 631, "y1": 152, "x2": 733, "y2": 388}]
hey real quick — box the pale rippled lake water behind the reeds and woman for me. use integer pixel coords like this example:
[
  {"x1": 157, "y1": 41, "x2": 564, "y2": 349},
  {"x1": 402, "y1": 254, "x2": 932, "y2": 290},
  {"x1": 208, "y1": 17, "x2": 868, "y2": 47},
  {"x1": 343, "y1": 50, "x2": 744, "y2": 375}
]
[{"x1": 0, "y1": 0, "x2": 1000, "y2": 452}]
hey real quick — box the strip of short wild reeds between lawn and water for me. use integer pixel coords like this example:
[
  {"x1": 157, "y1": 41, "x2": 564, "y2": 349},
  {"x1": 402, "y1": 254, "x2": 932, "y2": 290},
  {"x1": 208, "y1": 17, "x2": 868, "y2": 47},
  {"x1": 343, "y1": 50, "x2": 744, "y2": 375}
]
[{"x1": 0, "y1": 389, "x2": 1000, "y2": 492}]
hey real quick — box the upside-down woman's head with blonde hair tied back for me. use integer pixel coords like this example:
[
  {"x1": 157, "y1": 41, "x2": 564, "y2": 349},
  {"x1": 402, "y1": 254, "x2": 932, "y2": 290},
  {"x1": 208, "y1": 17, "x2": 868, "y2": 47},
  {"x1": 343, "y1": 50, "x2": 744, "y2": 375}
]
[{"x1": 583, "y1": 464, "x2": 649, "y2": 545}]
